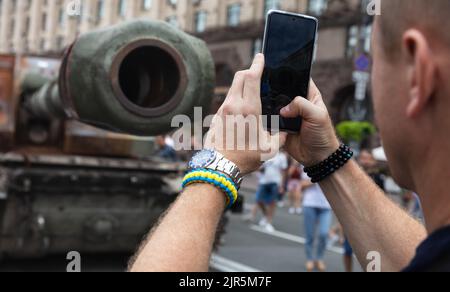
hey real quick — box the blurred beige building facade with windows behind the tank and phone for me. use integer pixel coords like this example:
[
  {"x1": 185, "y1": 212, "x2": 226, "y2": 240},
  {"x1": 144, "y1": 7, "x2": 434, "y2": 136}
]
[{"x1": 0, "y1": 0, "x2": 372, "y2": 122}]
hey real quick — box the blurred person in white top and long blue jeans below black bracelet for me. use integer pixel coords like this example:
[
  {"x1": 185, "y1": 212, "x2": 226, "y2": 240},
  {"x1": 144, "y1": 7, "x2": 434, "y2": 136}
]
[{"x1": 302, "y1": 172, "x2": 332, "y2": 272}]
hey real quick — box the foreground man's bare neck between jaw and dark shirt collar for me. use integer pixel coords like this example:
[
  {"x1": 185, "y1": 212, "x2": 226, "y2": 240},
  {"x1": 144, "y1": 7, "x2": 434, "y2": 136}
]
[{"x1": 414, "y1": 143, "x2": 450, "y2": 234}]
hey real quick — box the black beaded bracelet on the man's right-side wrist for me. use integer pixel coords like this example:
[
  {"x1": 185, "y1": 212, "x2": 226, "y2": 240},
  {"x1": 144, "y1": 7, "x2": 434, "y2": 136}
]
[{"x1": 305, "y1": 144, "x2": 353, "y2": 183}]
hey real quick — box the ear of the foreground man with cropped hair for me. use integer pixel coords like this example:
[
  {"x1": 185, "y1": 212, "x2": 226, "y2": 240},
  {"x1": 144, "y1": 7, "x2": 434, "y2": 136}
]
[{"x1": 402, "y1": 29, "x2": 437, "y2": 118}]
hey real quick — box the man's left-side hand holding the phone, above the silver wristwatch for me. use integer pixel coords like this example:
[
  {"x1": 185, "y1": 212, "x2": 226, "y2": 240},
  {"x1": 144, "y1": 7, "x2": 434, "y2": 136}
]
[{"x1": 205, "y1": 54, "x2": 286, "y2": 175}]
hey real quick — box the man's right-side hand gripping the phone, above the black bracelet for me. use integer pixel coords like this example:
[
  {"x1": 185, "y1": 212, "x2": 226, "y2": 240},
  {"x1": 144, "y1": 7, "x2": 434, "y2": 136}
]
[{"x1": 281, "y1": 80, "x2": 339, "y2": 167}]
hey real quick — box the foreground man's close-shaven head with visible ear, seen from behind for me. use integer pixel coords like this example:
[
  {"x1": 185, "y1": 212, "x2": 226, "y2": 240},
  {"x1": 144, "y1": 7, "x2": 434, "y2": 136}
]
[{"x1": 372, "y1": 0, "x2": 450, "y2": 190}]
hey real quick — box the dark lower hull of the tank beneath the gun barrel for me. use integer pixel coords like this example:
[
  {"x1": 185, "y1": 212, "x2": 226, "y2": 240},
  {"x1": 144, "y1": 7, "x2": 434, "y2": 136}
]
[{"x1": 0, "y1": 155, "x2": 183, "y2": 258}]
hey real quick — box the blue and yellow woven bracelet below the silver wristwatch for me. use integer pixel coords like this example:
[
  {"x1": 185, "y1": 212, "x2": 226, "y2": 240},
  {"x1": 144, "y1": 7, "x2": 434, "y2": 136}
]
[{"x1": 183, "y1": 169, "x2": 238, "y2": 208}]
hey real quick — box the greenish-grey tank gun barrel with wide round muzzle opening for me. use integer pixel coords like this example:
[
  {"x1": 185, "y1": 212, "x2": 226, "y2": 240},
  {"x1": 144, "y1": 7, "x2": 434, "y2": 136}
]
[{"x1": 22, "y1": 20, "x2": 215, "y2": 136}]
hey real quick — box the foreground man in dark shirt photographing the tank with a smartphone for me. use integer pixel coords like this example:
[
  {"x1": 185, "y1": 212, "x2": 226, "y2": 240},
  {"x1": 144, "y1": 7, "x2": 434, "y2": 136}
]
[{"x1": 131, "y1": 0, "x2": 450, "y2": 272}]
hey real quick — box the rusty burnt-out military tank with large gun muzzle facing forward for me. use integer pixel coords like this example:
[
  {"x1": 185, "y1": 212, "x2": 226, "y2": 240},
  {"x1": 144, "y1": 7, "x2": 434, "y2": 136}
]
[{"x1": 0, "y1": 20, "x2": 214, "y2": 258}]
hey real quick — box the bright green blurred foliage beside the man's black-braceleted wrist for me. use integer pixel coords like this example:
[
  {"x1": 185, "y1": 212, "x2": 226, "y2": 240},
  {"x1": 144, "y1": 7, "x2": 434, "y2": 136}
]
[{"x1": 336, "y1": 121, "x2": 377, "y2": 143}]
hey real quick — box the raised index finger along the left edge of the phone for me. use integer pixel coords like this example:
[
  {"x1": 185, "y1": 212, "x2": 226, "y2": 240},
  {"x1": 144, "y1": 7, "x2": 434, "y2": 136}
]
[{"x1": 243, "y1": 54, "x2": 265, "y2": 104}]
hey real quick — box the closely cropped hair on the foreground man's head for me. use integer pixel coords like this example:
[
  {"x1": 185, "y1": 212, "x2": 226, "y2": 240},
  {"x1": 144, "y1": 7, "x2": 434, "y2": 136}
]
[{"x1": 378, "y1": 0, "x2": 450, "y2": 56}]
